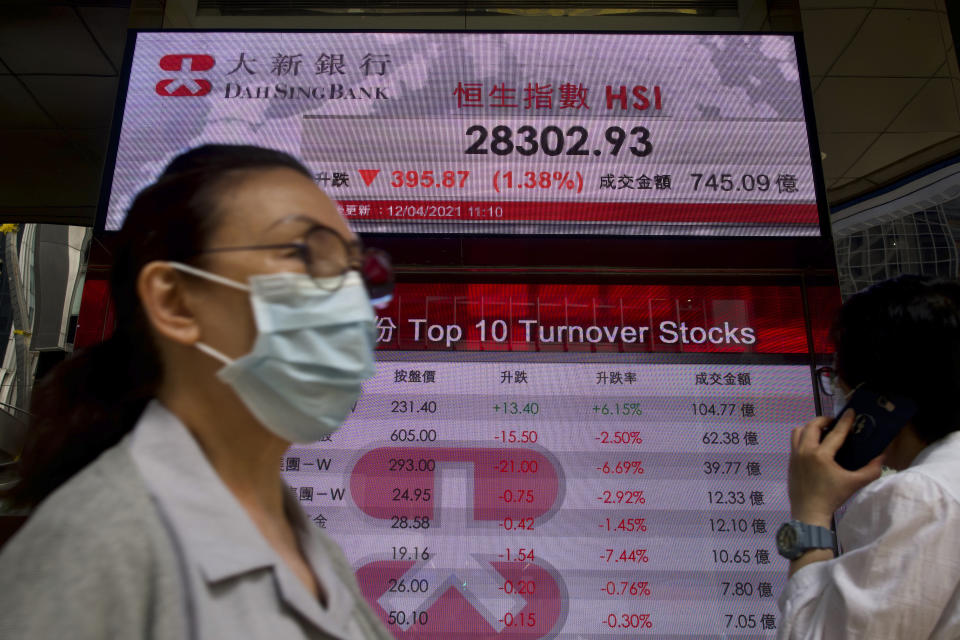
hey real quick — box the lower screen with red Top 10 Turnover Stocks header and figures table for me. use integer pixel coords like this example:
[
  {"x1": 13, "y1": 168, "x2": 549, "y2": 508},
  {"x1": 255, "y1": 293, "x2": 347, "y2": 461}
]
[{"x1": 281, "y1": 284, "x2": 822, "y2": 640}]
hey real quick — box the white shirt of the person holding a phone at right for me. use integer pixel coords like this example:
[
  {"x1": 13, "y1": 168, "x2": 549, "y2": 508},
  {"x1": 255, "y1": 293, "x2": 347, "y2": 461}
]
[{"x1": 777, "y1": 432, "x2": 960, "y2": 640}]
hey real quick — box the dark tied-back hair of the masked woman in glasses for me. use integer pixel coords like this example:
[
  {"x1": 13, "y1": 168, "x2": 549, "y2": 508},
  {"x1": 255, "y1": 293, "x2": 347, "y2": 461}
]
[{"x1": 2, "y1": 145, "x2": 311, "y2": 506}]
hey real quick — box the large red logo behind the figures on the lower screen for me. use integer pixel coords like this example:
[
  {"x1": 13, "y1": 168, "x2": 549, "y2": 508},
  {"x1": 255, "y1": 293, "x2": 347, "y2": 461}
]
[{"x1": 350, "y1": 443, "x2": 567, "y2": 640}]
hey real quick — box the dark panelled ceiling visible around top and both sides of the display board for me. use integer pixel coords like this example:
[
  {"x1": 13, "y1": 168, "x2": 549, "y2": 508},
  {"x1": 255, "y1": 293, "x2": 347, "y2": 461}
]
[{"x1": 0, "y1": 0, "x2": 960, "y2": 222}]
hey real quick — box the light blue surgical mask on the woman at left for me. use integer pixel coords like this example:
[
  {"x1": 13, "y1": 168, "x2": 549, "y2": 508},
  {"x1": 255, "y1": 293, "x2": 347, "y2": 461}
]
[{"x1": 170, "y1": 262, "x2": 376, "y2": 443}]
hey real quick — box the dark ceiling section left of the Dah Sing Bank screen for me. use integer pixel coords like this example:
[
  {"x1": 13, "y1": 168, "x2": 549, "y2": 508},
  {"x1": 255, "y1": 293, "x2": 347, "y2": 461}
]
[{"x1": 0, "y1": 3, "x2": 130, "y2": 222}]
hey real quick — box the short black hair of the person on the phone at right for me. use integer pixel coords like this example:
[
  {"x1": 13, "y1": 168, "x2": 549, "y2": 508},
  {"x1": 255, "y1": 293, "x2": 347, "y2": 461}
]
[{"x1": 833, "y1": 275, "x2": 960, "y2": 444}]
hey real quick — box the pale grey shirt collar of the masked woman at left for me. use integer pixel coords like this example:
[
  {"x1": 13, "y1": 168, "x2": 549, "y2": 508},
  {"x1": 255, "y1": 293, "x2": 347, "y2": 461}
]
[{"x1": 131, "y1": 400, "x2": 353, "y2": 633}]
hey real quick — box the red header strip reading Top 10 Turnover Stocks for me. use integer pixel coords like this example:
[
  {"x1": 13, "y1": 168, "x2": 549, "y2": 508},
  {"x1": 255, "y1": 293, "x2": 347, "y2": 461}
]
[{"x1": 377, "y1": 284, "x2": 808, "y2": 354}]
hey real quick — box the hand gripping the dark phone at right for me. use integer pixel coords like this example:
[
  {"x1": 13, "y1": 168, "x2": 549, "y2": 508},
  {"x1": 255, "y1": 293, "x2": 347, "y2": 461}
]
[{"x1": 789, "y1": 409, "x2": 883, "y2": 527}]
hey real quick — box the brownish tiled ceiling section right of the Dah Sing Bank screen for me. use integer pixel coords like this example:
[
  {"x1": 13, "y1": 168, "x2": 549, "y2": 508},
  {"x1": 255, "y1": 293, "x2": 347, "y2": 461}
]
[{"x1": 800, "y1": 0, "x2": 960, "y2": 203}]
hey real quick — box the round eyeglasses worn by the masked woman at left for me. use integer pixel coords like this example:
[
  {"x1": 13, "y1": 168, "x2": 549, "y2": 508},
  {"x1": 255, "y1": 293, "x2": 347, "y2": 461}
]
[{"x1": 200, "y1": 224, "x2": 394, "y2": 304}]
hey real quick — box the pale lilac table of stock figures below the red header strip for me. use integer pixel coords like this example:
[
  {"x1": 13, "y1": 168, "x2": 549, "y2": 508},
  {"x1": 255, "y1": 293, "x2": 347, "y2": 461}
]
[{"x1": 287, "y1": 362, "x2": 813, "y2": 638}]
